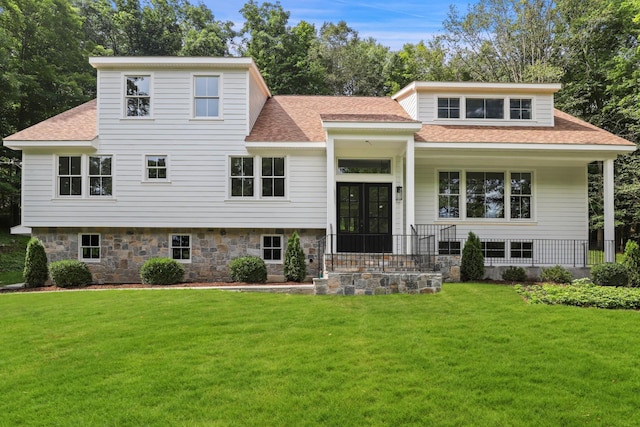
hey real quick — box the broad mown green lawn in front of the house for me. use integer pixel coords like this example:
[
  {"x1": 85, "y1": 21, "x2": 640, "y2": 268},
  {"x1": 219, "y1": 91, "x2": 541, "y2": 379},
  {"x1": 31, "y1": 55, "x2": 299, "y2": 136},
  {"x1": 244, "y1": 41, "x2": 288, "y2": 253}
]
[{"x1": 0, "y1": 284, "x2": 640, "y2": 426}]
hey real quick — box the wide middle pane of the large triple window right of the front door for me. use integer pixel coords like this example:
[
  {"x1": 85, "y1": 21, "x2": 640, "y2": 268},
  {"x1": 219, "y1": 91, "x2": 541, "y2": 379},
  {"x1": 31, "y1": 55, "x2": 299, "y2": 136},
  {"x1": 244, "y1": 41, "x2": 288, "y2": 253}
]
[{"x1": 466, "y1": 172, "x2": 504, "y2": 218}]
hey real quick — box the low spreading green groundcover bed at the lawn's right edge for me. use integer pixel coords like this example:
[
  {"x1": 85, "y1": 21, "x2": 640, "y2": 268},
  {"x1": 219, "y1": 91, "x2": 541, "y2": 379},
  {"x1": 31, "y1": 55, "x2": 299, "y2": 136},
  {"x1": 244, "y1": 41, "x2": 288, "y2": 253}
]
[{"x1": 516, "y1": 283, "x2": 640, "y2": 310}]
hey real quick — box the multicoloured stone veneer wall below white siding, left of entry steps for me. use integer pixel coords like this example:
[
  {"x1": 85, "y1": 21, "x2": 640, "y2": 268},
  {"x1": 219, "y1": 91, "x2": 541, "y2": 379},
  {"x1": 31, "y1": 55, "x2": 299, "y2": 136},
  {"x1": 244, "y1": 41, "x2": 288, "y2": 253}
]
[{"x1": 32, "y1": 228, "x2": 325, "y2": 283}]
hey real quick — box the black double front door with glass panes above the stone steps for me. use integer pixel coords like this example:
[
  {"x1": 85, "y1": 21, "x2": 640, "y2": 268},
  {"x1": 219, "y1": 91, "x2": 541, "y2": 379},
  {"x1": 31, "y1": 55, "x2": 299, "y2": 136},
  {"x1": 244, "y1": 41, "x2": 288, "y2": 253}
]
[{"x1": 337, "y1": 182, "x2": 393, "y2": 253}]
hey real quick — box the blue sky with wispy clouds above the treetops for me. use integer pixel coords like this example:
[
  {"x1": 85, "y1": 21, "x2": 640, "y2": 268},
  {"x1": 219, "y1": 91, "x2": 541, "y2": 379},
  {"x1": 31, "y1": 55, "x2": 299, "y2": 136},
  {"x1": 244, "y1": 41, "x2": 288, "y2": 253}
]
[{"x1": 202, "y1": 0, "x2": 474, "y2": 50}]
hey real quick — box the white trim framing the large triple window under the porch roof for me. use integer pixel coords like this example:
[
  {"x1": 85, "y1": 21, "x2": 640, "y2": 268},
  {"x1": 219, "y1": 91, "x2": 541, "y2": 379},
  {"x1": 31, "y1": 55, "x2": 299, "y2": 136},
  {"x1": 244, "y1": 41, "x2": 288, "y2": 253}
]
[{"x1": 433, "y1": 168, "x2": 538, "y2": 224}]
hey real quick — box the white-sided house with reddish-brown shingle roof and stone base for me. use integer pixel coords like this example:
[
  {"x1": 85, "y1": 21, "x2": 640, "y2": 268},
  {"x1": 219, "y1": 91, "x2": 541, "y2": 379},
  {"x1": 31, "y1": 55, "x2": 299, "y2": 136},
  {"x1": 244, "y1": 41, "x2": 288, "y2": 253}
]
[{"x1": 5, "y1": 57, "x2": 636, "y2": 282}]
